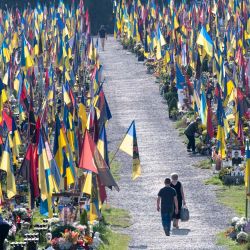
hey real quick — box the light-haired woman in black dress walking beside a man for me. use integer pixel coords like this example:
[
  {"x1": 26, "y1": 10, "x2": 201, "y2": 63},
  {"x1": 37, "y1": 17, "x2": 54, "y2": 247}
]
[{"x1": 170, "y1": 173, "x2": 186, "y2": 229}]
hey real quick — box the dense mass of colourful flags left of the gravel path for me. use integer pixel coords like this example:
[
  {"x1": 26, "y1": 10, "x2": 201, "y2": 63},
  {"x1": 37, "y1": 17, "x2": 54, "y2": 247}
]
[{"x1": 0, "y1": 0, "x2": 141, "y2": 221}]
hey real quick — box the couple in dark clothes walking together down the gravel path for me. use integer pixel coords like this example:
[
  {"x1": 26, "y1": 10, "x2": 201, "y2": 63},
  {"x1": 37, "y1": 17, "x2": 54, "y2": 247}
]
[{"x1": 157, "y1": 173, "x2": 186, "y2": 236}]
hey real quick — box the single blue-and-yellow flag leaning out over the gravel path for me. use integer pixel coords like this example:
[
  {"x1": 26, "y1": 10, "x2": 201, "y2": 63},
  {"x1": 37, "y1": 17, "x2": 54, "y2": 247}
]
[{"x1": 119, "y1": 121, "x2": 141, "y2": 180}]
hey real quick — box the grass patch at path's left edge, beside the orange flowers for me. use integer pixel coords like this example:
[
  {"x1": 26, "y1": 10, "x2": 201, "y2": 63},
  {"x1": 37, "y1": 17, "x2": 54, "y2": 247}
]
[{"x1": 95, "y1": 206, "x2": 131, "y2": 250}]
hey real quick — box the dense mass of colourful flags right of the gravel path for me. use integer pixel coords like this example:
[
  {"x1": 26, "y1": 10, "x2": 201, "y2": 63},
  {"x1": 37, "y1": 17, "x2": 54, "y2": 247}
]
[{"x1": 114, "y1": 0, "x2": 250, "y2": 159}]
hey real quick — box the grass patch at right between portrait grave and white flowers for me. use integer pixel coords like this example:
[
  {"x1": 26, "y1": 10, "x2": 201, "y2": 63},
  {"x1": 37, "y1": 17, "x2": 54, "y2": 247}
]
[{"x1": 216, "y1": 186, "x2": 246, "y2": 216}]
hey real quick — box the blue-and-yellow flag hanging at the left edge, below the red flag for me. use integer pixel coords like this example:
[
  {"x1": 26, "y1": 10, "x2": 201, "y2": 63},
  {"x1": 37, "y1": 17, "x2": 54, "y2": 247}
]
[{"x1": 0, "y1": 136, "x2": 17, "y2": 199}]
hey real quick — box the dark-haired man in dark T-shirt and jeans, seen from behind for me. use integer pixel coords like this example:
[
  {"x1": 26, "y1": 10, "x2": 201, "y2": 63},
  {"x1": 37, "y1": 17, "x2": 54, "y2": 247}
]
[{"x1": 157, "y1": 178, "x2": 178, "y2": 236}]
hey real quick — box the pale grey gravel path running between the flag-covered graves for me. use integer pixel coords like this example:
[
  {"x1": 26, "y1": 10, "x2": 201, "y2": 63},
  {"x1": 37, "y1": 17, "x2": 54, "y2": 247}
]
[{"x1": 100, "y1": 38, "x2": 231, "y2": 250}]
